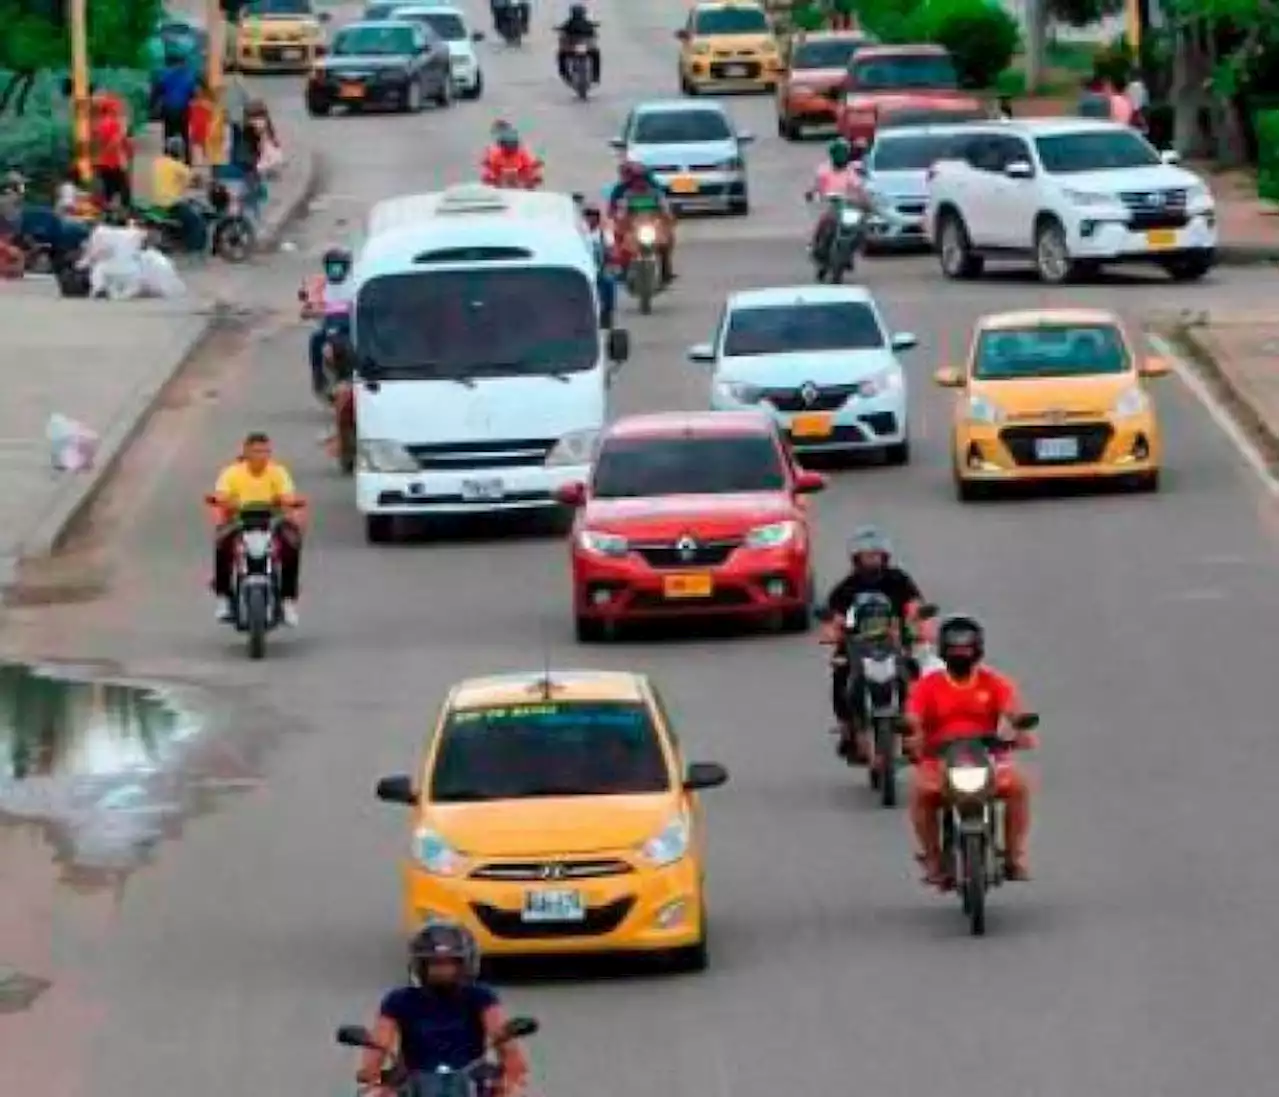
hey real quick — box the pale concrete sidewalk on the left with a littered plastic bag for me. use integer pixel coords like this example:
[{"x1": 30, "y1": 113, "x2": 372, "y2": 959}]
[{"x1": 0, "y1": 143, "x2": 316, "y2": 594}]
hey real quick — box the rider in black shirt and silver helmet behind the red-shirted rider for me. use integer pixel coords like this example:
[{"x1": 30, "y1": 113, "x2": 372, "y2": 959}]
[{"x1": 823, "y1": 526, "x2": 924, "y2": 762}]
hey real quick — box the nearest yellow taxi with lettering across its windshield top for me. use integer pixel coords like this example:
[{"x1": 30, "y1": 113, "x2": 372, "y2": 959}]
[{"x1": 378, "y1": 671, "x2": 728, "y2": 969}]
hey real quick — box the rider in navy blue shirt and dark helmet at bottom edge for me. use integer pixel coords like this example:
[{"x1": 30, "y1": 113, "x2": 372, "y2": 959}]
[{"x1": 356, "y1": 922, "x2": 529, "y2": 1097}]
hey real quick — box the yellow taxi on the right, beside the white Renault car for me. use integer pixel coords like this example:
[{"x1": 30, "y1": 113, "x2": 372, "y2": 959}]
[{"x1": 934, "y1": 308, "x2": 1169, "y2": 500}]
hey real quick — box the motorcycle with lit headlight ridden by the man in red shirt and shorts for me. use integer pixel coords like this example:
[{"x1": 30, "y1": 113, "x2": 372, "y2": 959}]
[{"x1": 941, "y1": 713, "x2": 1039, "y2": 937}]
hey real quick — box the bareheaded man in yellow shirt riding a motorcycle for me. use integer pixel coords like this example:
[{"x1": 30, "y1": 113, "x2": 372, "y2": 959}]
[{"x1": 214, "y1": 431, "x2": 302, "y2": 629}]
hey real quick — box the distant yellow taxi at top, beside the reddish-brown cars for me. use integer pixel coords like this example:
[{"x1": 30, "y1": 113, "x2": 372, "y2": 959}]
[{"x1": 676, "y1": 0, "x2": 783, "y2": 95}]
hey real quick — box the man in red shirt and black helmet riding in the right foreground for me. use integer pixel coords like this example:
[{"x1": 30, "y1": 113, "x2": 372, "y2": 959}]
[{"x1": 906, "y1": 616, "x2": 1030, "y2": 887}]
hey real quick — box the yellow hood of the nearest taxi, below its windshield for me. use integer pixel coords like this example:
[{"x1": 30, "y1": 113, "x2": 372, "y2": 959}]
[{"x1": 420, "y1": 792, "x2": 678, "y2": 858}]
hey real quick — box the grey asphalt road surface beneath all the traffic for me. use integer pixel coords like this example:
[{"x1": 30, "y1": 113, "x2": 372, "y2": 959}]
[{"x1": 0, "y1": 0, "x2": 1280, "y2": 1097}]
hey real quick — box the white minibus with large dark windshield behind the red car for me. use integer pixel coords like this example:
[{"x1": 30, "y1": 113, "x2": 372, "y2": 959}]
[{"x1": 352, "y1": 184, "x2": 628, "y2": 543}]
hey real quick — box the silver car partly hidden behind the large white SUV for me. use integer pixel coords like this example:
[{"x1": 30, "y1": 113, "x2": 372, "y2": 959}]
[{"x1": 863, "y1": 123, "x2": 988, "y2": 247}]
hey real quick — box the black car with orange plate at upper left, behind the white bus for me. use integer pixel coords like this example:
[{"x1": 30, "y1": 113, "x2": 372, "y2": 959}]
[{"x1": 306, "y1": 19, "x2": 453, "y2": 116}]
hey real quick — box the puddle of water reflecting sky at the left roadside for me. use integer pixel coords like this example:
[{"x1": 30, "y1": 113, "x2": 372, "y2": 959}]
[{"x1": 0, "y1": 662, "x2": 266, "y2": 887}]
